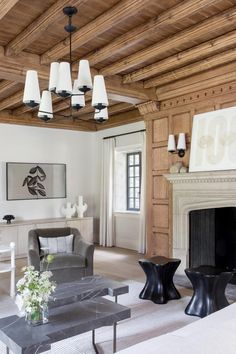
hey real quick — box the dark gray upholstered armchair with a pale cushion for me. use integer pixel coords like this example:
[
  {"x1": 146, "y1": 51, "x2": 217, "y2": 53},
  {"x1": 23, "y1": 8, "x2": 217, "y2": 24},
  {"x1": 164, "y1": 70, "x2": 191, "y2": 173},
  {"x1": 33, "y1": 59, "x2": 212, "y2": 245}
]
[{"x1": 28, "y1": 227, "x2": 94, "y2": 283}]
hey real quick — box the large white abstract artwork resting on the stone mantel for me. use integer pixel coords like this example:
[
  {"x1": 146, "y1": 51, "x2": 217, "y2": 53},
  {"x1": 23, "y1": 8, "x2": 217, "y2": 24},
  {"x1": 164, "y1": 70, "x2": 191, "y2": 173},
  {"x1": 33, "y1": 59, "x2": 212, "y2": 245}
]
[{"x1": 189, "y1": 107, "x2": 236, "y2": 172}]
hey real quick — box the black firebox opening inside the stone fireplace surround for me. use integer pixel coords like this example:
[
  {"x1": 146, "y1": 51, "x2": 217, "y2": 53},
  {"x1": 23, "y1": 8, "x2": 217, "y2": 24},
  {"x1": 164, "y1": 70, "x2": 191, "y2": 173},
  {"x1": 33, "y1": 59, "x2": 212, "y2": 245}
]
[{"x1": 189, "y1": 207, "x2": 236, "y2": 282}]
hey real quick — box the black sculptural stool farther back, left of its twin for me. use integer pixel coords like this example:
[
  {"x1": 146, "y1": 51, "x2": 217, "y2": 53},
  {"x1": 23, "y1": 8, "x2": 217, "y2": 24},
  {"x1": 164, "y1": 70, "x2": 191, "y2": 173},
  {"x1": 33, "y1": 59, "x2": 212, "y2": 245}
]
[{"x1": 139, "y1": 256, "x2": 181, "y2": 304}]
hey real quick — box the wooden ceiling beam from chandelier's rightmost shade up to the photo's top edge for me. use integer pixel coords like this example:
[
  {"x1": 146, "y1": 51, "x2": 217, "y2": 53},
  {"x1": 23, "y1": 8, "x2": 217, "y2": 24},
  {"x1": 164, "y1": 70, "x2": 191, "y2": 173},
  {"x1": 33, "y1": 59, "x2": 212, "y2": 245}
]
[{"x1": 86, "y1": 0, "x2": 219, "y2": 65}]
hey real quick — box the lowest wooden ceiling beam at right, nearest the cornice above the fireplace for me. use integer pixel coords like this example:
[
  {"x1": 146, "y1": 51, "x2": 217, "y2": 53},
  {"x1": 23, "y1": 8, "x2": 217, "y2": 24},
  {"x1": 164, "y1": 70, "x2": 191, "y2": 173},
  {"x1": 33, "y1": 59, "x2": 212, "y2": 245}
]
[{"x1": 144, "y1": 48, "x2": 236, "y2": 88}]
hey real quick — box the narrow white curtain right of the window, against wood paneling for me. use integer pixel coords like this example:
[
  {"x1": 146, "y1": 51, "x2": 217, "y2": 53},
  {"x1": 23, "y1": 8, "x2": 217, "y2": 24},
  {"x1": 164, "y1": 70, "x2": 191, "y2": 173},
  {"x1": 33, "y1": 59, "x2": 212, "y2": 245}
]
[{"x1": 138, "y1": 132, "x2": 146, "y2": 253}]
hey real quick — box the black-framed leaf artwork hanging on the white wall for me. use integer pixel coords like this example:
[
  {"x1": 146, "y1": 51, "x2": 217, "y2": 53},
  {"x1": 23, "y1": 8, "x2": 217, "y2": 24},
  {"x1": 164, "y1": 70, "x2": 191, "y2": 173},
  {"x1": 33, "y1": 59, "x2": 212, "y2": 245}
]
[{"x1": 6, "y1": 162, "x2": 66, "y2": 200}]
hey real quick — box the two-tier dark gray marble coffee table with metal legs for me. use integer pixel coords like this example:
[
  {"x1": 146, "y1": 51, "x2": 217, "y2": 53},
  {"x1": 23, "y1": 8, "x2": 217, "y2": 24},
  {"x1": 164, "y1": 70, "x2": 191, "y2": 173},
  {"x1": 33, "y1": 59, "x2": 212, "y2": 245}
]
[{"x1": 0, "y1": 276, "x2": 130, "y2": 354}]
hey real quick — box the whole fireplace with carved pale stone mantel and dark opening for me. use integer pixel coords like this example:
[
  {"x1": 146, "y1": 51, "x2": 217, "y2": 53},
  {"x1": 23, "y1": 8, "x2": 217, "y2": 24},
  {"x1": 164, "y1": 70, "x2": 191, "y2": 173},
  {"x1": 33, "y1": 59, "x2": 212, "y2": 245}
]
[{"x1": 165, "y1": 171, "x2": 236, "y2": 274}]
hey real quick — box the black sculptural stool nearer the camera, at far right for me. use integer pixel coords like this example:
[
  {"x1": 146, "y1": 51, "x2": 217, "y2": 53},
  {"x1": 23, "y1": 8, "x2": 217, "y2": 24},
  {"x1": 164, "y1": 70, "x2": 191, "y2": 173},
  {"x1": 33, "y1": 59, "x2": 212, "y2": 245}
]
[{"x1": 185, "y1": 266, "x2": 233, "y2": 317}]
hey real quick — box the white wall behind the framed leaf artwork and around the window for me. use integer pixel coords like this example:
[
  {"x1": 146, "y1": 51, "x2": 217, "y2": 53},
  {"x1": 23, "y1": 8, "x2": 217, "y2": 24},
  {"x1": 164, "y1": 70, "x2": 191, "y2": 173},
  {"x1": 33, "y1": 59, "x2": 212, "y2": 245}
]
[{"x1": 0, "y1": 122, "x2": 145, "y2": 249}]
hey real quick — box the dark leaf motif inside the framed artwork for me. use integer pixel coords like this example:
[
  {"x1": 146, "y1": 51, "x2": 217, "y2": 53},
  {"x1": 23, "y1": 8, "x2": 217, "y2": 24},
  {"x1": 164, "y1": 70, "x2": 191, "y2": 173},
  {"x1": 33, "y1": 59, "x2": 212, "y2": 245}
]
[{"x1": 22, "y1": 166, "x2": 46, "y2": 197}]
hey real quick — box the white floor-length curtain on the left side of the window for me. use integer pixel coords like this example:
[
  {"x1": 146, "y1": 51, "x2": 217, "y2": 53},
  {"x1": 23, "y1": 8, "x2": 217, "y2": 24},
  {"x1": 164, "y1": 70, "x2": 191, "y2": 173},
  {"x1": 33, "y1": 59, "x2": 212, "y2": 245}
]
[{"x1": 99, "y1": 138, "x2": 115, "y2": 247}]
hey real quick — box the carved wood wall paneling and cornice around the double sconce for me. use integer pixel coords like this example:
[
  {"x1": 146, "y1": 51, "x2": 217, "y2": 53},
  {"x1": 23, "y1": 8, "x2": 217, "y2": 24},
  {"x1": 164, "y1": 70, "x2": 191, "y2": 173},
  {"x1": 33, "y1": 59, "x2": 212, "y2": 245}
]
[{"x1": 139, "y1": 82, "x2": 236, "y2": 256}]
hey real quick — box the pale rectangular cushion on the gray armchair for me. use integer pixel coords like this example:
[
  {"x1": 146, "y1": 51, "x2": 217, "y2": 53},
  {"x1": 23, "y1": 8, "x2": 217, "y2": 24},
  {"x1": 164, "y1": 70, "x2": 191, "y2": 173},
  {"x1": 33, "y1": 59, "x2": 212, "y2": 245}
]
[{"x1": 39, "y1": 234, "x2": 74, "y2": 254}]
